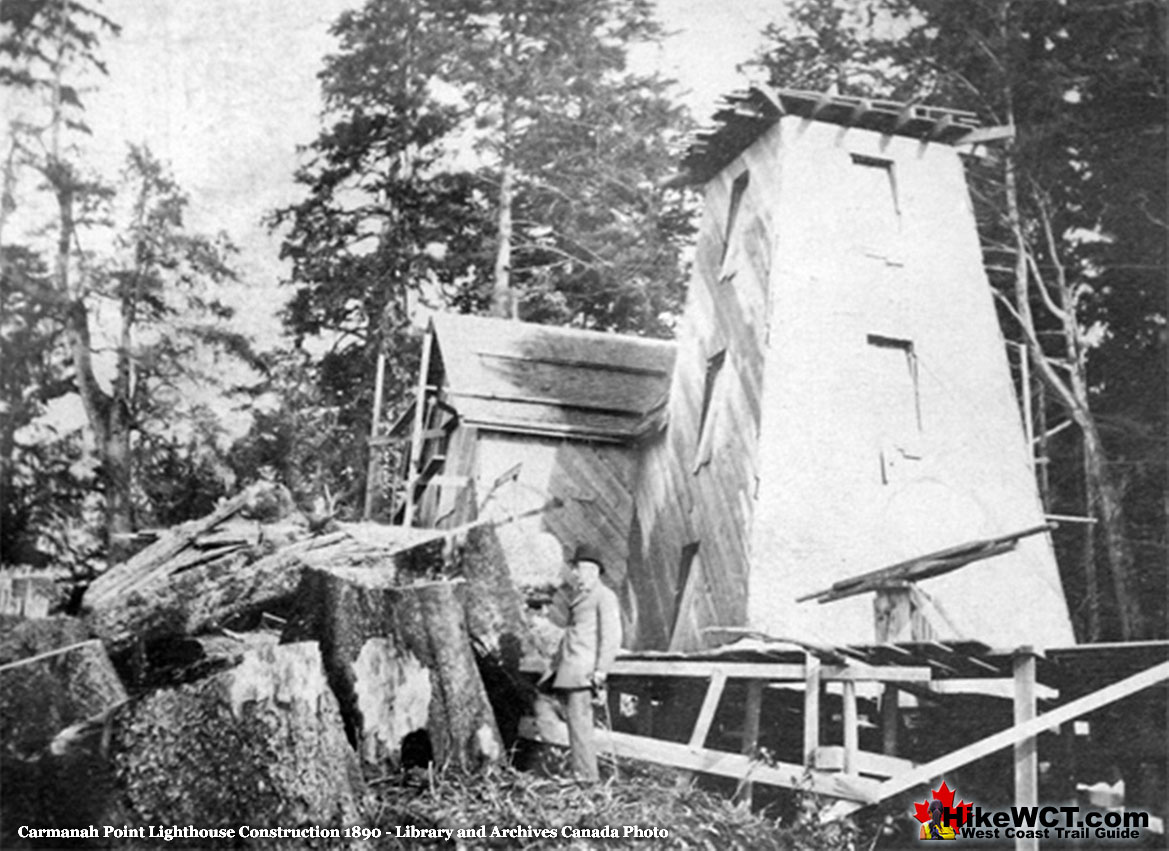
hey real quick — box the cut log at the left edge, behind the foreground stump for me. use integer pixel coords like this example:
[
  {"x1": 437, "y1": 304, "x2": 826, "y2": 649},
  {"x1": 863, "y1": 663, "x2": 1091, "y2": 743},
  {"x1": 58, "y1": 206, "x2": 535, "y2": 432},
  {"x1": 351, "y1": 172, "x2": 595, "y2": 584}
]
[{"x1": 0, "y1": 638, "x2": 126, "y2": 759}]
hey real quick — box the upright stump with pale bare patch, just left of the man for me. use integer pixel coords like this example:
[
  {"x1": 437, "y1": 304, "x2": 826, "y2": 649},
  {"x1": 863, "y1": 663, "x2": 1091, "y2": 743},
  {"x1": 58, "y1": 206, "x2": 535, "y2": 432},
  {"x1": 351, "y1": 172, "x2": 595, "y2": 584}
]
[{"x1": 285, "y1": 568, "x2": 503, "y2": 768}]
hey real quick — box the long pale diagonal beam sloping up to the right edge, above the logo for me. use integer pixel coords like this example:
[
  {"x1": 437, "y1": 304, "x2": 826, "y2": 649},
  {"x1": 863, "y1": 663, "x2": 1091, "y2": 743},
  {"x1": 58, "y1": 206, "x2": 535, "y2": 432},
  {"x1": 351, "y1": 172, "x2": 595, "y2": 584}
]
[{"x1": 822, "y1": 662, "x2": 1169, "y2": 822}]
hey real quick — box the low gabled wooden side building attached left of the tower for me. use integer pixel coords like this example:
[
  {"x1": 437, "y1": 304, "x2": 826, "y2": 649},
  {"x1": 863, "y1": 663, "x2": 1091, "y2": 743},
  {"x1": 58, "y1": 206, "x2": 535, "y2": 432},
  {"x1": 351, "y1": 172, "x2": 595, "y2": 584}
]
[{"x1": 395, "y1": 314, "x2": 675, "y2": 596}]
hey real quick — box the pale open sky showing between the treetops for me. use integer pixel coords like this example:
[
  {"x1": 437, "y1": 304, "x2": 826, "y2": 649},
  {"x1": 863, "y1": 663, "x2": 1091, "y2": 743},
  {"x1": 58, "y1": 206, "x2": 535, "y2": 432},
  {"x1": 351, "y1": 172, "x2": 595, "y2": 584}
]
[{"x1": 85, "y1": 0, "x2": 786, "y2": 313}]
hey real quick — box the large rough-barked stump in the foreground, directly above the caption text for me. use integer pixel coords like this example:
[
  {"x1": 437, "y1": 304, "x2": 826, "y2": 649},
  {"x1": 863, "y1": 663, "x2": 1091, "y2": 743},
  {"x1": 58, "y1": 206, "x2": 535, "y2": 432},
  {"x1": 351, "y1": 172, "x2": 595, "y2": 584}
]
[{"x1": 112, "y1": 643, "x2": 361, "y2": 846}]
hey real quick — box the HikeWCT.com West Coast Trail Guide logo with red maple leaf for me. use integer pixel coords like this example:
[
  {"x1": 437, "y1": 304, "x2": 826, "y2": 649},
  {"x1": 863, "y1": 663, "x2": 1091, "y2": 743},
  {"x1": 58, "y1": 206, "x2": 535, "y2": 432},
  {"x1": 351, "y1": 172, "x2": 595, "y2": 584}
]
[{"x1": 913, "y1": 780, "x2": 1149, "y2": 839}]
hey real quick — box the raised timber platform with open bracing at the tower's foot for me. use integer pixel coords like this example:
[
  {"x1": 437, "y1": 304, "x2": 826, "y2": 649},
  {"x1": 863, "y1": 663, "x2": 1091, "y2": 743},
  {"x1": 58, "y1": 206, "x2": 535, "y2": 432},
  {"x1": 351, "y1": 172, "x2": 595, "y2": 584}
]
[{"x1": 521, "y1": 638, "x2": 1169, "y2": 847}]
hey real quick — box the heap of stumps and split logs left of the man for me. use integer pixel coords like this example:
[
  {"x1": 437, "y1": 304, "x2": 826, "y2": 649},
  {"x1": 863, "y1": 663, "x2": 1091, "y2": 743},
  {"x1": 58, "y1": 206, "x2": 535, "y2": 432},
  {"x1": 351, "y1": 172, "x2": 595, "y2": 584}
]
[{"x1": 0, "y1": 485, "x2": 532, "y2": 846}]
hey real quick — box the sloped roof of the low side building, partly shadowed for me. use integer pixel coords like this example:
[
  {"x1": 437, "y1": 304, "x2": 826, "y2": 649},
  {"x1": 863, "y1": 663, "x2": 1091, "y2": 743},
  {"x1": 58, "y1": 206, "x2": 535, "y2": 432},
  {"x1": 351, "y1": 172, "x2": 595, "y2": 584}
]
[{"x1": 431, "y1": 313, "x2": 675, "y2": 443}]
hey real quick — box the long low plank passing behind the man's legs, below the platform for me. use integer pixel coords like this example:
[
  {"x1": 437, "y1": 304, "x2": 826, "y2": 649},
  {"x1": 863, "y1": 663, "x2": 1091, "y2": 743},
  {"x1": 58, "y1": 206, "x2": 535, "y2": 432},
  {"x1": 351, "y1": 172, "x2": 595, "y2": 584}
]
[{"x1": 519, "y1": 717, "x2": 879, "y2": 805}]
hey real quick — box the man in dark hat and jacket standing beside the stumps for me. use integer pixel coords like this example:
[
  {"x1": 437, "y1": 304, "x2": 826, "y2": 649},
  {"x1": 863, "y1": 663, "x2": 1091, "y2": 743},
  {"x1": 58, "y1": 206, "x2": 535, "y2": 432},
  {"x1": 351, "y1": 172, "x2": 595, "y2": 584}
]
[{"x1": 549, "y1": 544, "x2": 621, "y2": 782}]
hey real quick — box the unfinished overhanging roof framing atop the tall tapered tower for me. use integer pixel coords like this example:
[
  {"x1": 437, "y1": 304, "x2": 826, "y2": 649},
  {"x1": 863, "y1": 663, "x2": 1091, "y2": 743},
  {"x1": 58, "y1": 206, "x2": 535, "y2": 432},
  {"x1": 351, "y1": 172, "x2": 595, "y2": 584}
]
[{"x1": 677, "y1": 87, "x2": 978, "y2": 184}]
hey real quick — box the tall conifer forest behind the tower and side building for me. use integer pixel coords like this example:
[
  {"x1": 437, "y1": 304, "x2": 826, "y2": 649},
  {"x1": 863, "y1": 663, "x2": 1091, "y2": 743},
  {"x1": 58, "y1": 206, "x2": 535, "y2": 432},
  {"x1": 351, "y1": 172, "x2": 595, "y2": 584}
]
[{"x1": 0, "y1": 0, "x2": 1169, "y2": 639}]
